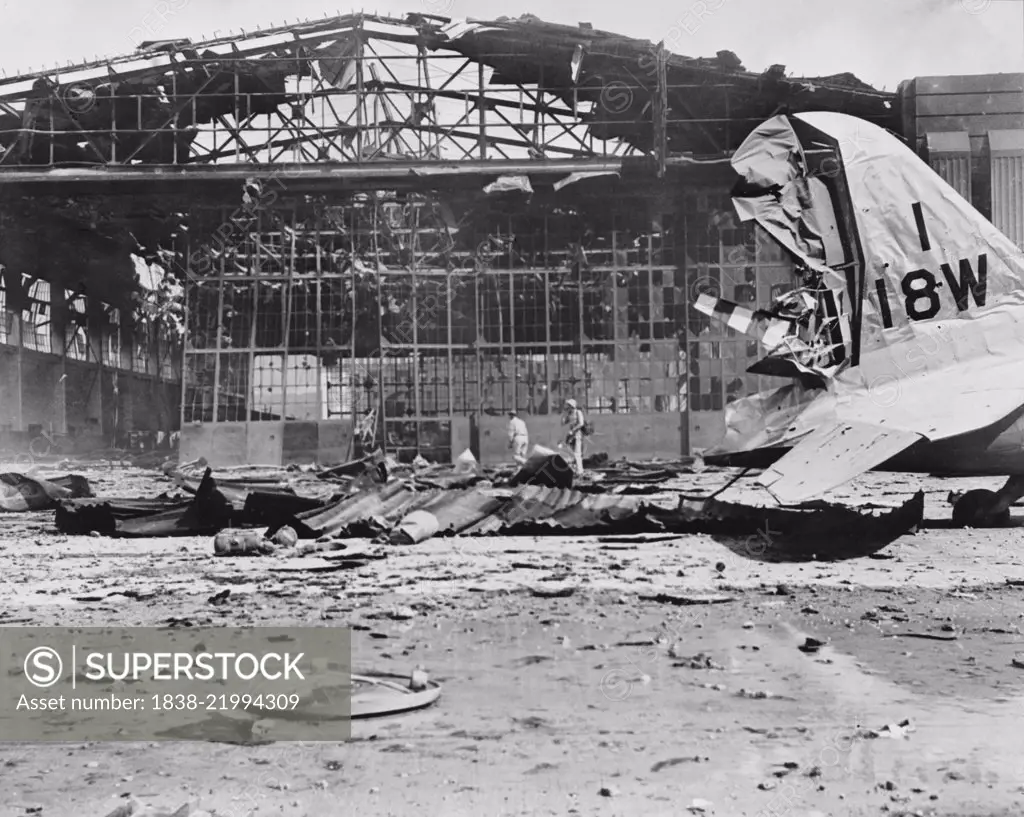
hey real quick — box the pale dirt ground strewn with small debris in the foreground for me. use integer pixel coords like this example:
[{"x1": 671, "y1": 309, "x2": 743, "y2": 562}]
[{"x1": 0, "y1": 471, "x2": 1024, "y2": 817}]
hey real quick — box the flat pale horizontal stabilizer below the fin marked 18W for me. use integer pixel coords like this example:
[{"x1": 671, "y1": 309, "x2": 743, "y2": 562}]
[{"x1": 758, "y1": 422, "x2": 924, "y2": 505}]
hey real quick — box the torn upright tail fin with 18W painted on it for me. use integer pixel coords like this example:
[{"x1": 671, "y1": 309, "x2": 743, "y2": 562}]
[{"x1": 732, "y1": 113, "x2": 1024, "y2": 397}]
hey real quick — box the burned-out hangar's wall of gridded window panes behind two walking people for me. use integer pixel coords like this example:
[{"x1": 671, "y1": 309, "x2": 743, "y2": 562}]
[{"x1": 181, "y1": 184, "x2": 794, "y2": 465}]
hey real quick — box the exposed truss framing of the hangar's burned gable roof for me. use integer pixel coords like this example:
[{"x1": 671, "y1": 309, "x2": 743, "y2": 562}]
[{"x1": 0, "y1": 13, "x2": 896, "y2": 174}]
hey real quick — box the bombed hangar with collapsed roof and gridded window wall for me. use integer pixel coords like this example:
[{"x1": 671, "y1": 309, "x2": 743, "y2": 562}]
[{"x1": 0, "y1": 14, "x2": 900, "y2": 465}]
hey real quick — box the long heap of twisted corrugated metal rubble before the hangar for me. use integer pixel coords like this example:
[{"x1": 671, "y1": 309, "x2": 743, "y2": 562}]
[{"x1": 19, "y1": 454, "x2": 924, "y2": 565}]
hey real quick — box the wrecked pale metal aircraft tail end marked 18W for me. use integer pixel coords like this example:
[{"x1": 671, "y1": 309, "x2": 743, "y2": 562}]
[{"x1": 697, "y1": 113, "x2": 1024, "y2": 525}]
